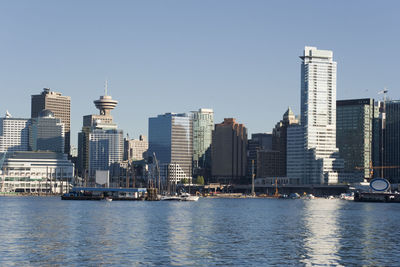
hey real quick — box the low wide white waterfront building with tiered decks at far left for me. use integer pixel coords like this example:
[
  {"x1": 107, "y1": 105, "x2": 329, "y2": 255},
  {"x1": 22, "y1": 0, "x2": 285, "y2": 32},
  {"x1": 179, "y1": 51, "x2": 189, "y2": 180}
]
[{"x1": 0, "y1": 151, "x2": 74, "y2": 193}]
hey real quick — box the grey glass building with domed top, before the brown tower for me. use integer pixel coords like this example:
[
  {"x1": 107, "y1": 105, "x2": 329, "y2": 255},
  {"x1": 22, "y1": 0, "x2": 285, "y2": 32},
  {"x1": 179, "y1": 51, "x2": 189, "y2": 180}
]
[{"x1": 29, "y1": 109, "x2": 65, "y2": 153}]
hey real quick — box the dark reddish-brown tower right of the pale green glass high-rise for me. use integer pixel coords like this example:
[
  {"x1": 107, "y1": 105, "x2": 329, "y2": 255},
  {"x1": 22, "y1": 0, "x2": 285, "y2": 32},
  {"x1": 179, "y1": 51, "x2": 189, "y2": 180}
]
[{"x1": 211, "y1": 118, "x2": 248, "y2": 184}]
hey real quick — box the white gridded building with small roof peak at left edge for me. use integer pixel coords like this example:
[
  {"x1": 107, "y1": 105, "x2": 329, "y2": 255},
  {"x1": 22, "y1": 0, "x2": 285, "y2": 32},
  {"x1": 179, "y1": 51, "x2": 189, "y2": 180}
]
[{"x1": 0, "y1": 111, "x2": 31, "y2": 153}]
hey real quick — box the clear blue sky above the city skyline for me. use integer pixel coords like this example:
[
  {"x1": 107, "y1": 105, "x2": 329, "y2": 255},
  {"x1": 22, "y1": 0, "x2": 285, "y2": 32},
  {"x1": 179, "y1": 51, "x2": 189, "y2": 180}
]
[{"x1": 0, "y1": 0, "x2": 400, "y2": 147}]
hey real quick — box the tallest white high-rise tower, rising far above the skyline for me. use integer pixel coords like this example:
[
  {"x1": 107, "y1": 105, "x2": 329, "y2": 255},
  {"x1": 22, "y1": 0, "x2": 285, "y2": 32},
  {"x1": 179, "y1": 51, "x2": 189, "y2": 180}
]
[{"x1": 300, "y1": 46, "x2": 343, "y2": 184}]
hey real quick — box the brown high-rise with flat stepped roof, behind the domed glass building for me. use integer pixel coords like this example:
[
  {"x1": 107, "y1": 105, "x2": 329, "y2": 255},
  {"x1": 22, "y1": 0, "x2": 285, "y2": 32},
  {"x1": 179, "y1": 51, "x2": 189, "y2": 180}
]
[{"x1": 31, "y1": 88, "x2": 71, "y2": 154}]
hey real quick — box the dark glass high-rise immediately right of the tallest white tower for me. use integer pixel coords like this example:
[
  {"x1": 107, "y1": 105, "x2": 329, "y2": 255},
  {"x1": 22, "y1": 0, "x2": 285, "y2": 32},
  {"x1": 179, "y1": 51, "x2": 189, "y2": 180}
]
[{"x1": 336, "y1": 98, "x2": 375, "y2": 183}]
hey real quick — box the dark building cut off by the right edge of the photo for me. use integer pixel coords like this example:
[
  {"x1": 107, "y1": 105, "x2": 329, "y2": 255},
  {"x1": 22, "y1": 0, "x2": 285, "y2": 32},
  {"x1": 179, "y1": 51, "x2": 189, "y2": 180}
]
[{"x1": 383, "y1": 100, "x2": 400, "y2": 183}]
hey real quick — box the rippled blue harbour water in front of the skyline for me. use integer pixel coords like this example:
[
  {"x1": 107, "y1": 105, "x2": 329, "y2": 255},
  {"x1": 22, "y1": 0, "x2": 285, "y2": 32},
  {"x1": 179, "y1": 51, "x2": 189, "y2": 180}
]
[{"x1": 0, "y1": 197, "x2": 400, "y2": 266}]
